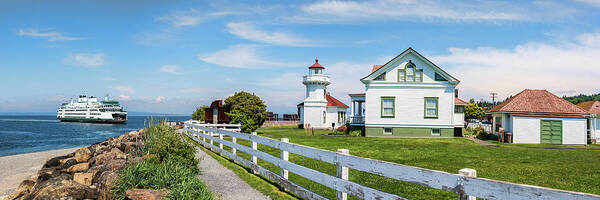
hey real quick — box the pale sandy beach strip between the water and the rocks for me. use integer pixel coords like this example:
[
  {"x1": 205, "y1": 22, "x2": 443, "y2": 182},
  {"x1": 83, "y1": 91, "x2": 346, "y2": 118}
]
[{"x1": 0, "y1": 147, "x2": 81, "y2": 200}]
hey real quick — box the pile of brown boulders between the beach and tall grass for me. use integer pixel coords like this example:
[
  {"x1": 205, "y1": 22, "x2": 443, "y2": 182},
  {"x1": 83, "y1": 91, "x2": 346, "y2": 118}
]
[{"x1": 7, "y1": 129, "x2": 144, "y2": 200}]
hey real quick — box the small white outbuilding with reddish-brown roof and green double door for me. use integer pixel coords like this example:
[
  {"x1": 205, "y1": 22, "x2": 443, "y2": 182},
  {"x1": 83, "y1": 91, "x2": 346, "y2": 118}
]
[{"x1": 488, "y1": 89, "x2": 587, "y2": 144}]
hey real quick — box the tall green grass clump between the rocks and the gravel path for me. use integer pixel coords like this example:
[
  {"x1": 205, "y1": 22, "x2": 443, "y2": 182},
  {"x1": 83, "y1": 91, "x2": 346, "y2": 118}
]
[{"x1": 113, "y1": 123, "x2": 214, "y2": 200}]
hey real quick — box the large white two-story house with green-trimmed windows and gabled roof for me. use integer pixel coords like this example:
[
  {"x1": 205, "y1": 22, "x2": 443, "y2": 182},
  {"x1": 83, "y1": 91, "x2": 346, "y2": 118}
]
[{"x1": 350, "y1": 48, "x2": 466, "y2": 137}]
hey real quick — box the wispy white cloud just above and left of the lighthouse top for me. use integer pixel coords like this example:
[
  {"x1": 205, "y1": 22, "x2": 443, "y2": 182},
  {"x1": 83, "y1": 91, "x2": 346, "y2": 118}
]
[{"x1": 198, "y1": 45, "x2": 295, "y2": 69}]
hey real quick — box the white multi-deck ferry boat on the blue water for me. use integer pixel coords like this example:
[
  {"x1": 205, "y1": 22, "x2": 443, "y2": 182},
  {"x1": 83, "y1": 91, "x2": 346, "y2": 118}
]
[{"x1": 56, "y1": 95, "x2": 127, "y2": 123}]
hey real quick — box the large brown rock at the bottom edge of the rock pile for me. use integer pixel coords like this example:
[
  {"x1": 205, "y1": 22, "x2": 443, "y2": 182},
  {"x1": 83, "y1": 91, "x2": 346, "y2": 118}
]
[{"x1": 23, "y1": 174, "x2": 98, "y2": 199}]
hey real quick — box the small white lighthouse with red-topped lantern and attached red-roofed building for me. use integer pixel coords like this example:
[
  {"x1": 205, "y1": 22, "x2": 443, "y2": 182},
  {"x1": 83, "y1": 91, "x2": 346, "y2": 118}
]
[{"x1": 298, "y1": 59, "x2": 348, "y2": 129}]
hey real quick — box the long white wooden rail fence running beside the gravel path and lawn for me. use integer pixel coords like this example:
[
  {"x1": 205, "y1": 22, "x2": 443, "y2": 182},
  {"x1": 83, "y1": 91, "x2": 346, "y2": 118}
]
[{"x1": 184, "y1": 123, "x2": 600, "y2": 200}]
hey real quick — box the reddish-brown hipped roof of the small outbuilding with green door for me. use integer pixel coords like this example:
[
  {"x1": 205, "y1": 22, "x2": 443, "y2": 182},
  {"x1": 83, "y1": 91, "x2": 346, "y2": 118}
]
[{"x1": 488, "y1": 89, "x2": 586, "y2": 114}]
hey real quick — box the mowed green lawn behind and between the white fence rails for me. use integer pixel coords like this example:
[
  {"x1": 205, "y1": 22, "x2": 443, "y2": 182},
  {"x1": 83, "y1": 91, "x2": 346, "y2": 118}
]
[{"x1": 192, "y1": 127, "x2": 600, "y2": 199}]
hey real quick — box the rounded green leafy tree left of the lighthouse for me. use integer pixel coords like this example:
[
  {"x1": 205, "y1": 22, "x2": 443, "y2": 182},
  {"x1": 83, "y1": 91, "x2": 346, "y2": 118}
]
[{"x1": 225, "y1": 91, "x2": 267, "y2": 133}]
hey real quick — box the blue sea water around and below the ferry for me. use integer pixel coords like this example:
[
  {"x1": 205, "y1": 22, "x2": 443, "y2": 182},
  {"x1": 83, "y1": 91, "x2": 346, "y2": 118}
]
[{"x1": 0, "y1": 115, "x2": 191, "y2": 156}]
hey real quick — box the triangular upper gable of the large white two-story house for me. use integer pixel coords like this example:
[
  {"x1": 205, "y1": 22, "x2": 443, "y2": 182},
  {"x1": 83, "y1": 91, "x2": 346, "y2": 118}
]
[{"x1": 361, "y1": 48, "x2": 459, "y2": 84}]
